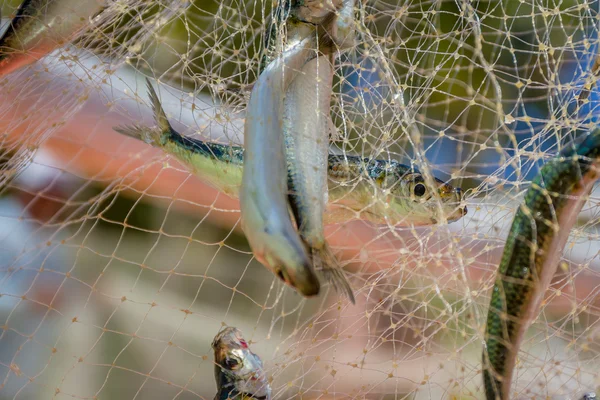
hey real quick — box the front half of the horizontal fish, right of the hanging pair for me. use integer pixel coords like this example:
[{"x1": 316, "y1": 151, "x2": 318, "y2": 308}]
[{"x1": 327, "y1": 155, "x2": 467, "y2": 226}]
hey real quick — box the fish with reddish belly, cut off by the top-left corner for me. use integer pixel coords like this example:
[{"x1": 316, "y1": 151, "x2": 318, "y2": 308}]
[{"x1": 0, "y1": 0, "x2": 107, "y2": 76}]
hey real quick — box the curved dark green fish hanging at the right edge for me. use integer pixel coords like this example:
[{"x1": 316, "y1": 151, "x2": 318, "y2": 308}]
[{"x1": 482, "y1": 130, "x2": 600, "y2": 400}]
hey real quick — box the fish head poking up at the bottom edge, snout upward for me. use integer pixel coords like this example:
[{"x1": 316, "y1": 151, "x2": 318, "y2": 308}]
[{"x1": 212, "y1": 327, "x2": 271, "y2": 400}]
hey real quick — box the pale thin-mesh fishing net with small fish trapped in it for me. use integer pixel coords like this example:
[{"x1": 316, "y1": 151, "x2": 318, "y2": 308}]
[{"x1": 0, "y1": 0, "x2": 600, "y2": 399}]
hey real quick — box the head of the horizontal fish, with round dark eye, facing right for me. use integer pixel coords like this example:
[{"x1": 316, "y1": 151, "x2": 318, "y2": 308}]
[{"x1": 380, "y1": 163, "x2": 467, "y2": 226}]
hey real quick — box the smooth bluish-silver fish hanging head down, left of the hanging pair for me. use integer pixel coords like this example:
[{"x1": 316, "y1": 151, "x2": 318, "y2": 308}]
[{"x1": 240, "y1": 17, "x2": 340, "y2": 297}]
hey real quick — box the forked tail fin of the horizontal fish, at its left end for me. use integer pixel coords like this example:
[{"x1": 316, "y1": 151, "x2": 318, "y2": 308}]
[{"x1": 113, "y1": 78, "x2": 173, "y2": 147}]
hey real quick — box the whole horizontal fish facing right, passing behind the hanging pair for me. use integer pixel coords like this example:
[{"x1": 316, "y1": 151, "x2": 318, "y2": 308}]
[{"x1": 114, "y1": 80, "x2": 467, "y2": 226}]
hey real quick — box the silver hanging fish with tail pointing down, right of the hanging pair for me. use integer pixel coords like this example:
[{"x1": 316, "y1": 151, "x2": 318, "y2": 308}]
[{"x1": 283, "y1": 39, "x2": 355, "y2": 303}]
